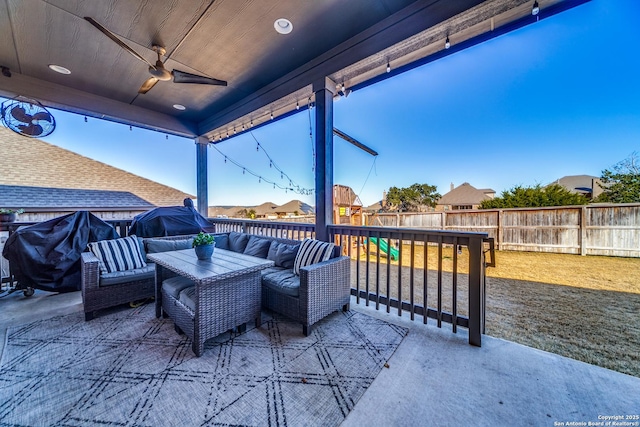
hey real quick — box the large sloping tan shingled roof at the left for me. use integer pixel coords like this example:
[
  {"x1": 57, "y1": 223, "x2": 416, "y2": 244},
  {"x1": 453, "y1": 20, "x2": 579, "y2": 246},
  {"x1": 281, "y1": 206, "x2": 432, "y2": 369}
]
[{"x1": 0, "y1": 128, "x2": 195, "y2": 206}]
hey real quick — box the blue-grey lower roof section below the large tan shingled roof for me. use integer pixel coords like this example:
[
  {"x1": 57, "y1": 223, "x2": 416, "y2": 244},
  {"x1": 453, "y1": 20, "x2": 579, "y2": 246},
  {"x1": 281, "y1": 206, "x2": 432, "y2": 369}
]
[{"x1": 0, "y1": 185, "x2": 154, "y2": 210}]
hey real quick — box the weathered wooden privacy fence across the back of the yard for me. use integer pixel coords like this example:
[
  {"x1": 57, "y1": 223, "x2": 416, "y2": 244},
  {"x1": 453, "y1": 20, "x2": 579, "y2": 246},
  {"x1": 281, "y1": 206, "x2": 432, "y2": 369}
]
[{"x1": 367, "y1": 203, "x2": 640, "y2": 257}]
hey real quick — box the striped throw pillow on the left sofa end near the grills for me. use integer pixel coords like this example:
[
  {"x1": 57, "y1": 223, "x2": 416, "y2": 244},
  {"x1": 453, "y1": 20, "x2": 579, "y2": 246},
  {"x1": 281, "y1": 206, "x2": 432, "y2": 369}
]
[{"x1": 88, "y1": 234, "x2": 147, "y2": 273}]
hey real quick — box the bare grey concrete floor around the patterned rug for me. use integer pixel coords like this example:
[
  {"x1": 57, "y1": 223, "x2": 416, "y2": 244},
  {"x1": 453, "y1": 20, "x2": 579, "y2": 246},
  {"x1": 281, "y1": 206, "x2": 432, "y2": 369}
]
[{"x1": 0, "y1": 291, "x2": 640, "y2": 426}]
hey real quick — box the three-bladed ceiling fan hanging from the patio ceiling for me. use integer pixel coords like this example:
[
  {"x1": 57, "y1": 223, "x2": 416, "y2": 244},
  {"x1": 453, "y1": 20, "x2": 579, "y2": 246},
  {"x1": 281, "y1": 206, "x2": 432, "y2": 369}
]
[{"x1": 84, "y1": 16, "x2": 227, "y2": 94}]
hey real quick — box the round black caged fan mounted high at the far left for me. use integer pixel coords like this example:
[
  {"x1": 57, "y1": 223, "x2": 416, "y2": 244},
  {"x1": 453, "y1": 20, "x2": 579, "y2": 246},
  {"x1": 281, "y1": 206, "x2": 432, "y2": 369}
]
[{"x1": 1, "y1": 98, "x2": 56, "y2": 138}]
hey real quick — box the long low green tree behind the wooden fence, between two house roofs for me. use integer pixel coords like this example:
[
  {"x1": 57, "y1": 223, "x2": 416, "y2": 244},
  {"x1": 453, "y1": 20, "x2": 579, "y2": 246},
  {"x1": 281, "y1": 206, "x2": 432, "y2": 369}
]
[{"x1": 480, "y1": 184, "x2": 589, "y2": 209}]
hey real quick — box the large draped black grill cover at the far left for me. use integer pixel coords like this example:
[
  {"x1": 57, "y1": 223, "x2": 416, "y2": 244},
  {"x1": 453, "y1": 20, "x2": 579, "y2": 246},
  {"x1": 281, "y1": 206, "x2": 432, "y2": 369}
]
[{"x1": 2, "y1": 211, "x2": 120, "y2": 292}]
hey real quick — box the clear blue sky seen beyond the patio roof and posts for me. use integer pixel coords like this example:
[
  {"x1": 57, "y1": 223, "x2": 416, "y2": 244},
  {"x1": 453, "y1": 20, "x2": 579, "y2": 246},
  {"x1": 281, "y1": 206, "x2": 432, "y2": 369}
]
[{"x1": 27, "y1": 0, "x2": 640, "y2": 205}]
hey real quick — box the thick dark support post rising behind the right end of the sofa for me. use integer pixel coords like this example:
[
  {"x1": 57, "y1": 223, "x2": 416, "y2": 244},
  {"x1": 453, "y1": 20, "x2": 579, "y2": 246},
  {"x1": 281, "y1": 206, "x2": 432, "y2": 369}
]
[{"x1": 313, "y1": 78, "x2": 336, "y2": 242}]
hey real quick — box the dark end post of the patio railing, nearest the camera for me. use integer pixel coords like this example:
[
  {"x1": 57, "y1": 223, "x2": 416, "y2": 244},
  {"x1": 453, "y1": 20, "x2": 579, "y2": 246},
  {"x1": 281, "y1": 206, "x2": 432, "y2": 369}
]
[{"x1": 469, "y1": 236, "x2": 484, "y2": 347}]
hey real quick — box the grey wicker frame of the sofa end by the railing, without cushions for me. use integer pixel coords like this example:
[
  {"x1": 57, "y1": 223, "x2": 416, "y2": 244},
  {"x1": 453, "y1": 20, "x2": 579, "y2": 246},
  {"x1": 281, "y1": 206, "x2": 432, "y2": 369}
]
[{"x1": 262, "y1": 239, "x2": 351, "y2": 336}]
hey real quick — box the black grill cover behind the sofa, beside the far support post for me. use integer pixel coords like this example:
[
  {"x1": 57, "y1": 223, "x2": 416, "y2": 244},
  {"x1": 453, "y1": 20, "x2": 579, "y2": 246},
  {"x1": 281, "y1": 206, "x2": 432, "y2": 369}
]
[{"x1": 129, "y1": 206, "x2": 215, "y2": 237}]
